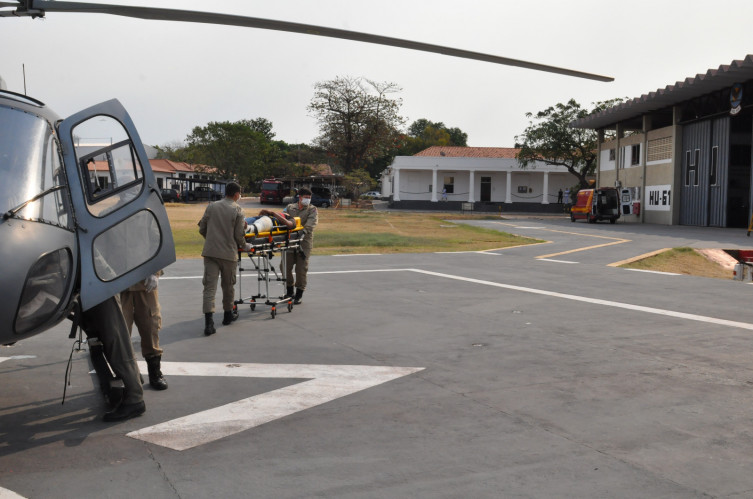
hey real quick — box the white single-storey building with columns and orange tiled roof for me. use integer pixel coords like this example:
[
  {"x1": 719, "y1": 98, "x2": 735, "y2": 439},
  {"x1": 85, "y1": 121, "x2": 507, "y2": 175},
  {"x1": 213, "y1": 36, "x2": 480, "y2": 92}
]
[{"x1": 382, "y1": 146, "x2": 578, "y2": 211}]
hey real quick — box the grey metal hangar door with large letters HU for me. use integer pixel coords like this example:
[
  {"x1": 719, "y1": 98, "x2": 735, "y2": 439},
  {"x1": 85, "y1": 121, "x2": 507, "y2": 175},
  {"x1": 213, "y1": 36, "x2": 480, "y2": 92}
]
[{"x1": 680, "y1": 117, "x2": 730, "y2": 227}]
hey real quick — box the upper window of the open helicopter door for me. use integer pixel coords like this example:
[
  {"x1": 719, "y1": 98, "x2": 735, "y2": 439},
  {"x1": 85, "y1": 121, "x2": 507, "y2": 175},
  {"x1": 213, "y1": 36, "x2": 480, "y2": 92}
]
[{"x1": 73, "y1": 116, "x2": 144, "y2": 217}]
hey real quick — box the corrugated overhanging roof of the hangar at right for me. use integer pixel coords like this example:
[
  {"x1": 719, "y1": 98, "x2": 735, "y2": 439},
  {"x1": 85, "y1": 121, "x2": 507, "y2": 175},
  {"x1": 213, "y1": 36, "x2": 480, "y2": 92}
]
[{"x1": 570, "y1": 55, "x2": 753, "y2": 129}]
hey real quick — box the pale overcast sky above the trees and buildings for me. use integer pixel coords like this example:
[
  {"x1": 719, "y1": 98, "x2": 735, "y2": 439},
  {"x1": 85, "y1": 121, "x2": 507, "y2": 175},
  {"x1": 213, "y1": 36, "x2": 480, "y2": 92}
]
[{"x1": 0, "y1": 0, "x2": 753, "y2": 147}]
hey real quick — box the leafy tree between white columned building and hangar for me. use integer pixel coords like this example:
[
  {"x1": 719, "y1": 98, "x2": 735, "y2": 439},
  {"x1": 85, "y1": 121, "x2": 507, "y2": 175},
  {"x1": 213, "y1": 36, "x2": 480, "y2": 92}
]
[{"x1": 515, "y1": 99, "x2": 622, "y2": 188}]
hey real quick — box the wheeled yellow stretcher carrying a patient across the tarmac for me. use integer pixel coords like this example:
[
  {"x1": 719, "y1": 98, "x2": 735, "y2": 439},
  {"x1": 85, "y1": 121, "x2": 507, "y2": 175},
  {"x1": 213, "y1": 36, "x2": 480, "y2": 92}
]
[{"x1": 233, "y1": 217, "x2": 306, "y2": 319}]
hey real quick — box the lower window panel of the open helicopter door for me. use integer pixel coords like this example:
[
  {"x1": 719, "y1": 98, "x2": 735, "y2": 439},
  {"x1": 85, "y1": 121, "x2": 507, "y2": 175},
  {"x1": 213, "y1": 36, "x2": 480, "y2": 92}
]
[{"x1": 92, "y1": 210, "x2": 162, "y2": 282}]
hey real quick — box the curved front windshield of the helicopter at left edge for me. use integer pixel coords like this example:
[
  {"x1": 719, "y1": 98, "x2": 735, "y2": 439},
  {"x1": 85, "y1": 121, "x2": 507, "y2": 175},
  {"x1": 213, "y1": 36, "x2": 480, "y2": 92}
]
[{"x1": 0, "y1": 106, "x2": 71, "y2": 228}]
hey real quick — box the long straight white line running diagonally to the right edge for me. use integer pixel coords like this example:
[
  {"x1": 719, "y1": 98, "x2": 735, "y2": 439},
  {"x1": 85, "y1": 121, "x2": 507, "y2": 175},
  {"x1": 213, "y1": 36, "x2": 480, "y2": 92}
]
[{"x1": 411, "y1": 269, "x2": 753, "y2": 331}]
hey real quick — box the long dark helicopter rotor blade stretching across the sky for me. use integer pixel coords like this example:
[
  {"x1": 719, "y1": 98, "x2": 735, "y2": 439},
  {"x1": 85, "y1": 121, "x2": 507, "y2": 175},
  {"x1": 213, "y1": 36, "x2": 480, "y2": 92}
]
[{"x1": 8, "y1": 0, "x2": 614, "y2": 82}]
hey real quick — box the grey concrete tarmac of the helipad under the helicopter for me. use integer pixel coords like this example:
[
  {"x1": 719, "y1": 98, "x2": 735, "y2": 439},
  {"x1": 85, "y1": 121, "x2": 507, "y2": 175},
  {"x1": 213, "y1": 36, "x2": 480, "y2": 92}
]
[{"x1": 0, "y1": 214, "x2": 753, "y2": 499}]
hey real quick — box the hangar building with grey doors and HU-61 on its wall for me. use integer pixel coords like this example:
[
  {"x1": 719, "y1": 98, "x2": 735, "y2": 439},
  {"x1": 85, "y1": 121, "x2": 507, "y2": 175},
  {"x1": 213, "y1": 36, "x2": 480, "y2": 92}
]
[{"x1": 571, "y1": 55, "x2": 753, "y2": 227}]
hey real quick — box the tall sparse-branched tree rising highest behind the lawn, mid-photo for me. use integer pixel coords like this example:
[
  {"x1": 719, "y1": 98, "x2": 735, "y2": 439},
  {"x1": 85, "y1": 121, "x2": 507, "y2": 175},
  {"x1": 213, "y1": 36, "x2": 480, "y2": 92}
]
[{"x1": 307, "y1": 77, "x2": 404, "y2": 173}]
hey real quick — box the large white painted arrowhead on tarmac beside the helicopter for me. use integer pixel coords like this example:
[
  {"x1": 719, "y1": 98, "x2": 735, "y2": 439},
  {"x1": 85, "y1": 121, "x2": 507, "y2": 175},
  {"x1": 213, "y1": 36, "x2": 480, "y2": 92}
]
[{"x1": 127, "y1": 362, "x2": 424, "y2": 450}]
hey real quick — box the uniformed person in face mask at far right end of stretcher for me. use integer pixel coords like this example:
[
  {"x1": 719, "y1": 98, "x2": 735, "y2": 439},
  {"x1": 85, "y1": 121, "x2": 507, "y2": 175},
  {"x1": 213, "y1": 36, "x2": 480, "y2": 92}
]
[{"x1": 285, "y1": 187, "x2": 319, "y2": 305}]
